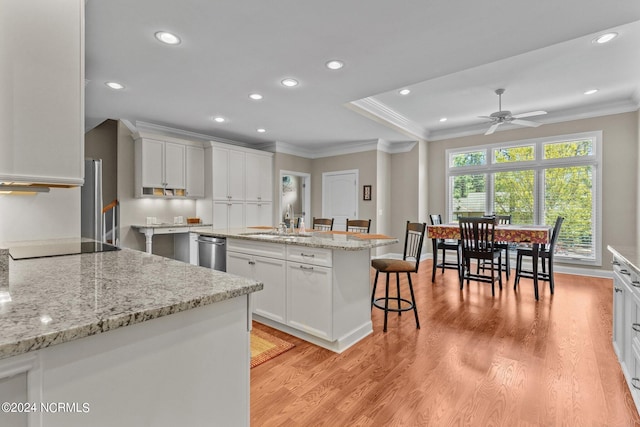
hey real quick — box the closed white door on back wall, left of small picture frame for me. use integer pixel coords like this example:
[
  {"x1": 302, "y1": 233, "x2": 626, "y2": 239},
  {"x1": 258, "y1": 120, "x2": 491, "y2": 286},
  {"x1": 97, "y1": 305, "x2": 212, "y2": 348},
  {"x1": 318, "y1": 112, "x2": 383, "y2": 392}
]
[{"x1": 322, "y1": 170, "x2": 358, "y2": 230}]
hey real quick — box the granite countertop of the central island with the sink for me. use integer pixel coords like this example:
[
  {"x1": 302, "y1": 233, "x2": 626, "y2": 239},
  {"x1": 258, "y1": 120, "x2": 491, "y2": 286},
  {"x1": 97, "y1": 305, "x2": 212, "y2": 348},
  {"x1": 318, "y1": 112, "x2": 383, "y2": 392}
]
[{"x1": 191, "y1": 227, "x2": 398, "y2": 251}]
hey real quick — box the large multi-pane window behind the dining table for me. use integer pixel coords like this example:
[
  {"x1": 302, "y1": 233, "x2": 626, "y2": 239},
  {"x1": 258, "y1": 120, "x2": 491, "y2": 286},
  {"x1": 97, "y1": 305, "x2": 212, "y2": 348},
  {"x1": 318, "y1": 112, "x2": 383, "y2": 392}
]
[{"x1": 447, "y1": 132, "x2": 602, "y2": 265}]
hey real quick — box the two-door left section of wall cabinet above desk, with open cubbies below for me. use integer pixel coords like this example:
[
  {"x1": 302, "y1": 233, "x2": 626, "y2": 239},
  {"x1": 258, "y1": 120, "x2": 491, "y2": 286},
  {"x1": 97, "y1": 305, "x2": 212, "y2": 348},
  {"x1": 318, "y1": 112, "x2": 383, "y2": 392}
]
[{"x1": 135, "y1": 138, "x2": 186, "y2": 196}]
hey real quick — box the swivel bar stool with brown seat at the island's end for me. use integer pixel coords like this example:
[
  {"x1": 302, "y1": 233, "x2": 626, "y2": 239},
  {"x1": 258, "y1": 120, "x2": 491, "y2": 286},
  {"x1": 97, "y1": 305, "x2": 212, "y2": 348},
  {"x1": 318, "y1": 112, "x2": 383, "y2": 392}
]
[{"x1": 371, "y1": 221, "x2": 427, "y2": 332}]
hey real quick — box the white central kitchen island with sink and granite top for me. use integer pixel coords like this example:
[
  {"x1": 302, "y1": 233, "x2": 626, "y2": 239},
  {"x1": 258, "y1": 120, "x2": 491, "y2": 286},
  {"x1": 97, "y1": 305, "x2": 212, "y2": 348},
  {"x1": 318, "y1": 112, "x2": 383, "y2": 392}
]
[{"x1": 194, "y1": 227, "x2": 398, "y2": 353}]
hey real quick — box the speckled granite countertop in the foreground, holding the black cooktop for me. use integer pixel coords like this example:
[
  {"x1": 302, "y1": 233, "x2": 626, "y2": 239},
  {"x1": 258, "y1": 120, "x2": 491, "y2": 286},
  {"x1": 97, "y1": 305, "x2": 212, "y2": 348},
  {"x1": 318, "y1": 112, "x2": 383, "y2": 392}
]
[{"x1": 0, "y1": 240, "x2": 263, "y2": 359}]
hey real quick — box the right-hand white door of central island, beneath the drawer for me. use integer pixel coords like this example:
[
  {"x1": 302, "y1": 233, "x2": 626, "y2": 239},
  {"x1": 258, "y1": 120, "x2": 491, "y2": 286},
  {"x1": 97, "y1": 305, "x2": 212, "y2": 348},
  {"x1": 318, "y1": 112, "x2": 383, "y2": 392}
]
[{"x1": 287, "y1": 261, "x2": 333, "y2": 341}]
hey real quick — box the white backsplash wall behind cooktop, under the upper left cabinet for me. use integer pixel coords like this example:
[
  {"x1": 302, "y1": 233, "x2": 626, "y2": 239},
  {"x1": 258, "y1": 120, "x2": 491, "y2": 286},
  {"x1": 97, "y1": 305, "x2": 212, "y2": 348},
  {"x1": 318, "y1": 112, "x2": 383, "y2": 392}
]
[{"x1": 0, "y1": 187, "x2": 80, "y2": 242}]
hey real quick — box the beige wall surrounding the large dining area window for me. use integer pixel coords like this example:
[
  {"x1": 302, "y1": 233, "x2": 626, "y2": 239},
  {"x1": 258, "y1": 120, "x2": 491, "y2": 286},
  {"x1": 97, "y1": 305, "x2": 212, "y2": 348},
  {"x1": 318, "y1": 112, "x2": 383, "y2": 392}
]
[{"x1": 428, "y1": 112, "x2": 640, "y2": 270}]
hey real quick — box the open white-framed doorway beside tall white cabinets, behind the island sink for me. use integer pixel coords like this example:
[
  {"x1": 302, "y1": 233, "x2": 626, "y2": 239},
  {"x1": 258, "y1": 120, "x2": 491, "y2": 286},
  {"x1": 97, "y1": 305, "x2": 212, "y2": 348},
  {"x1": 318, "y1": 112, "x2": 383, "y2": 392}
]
[{"x1": 278, "y1": 170, "x2": 311, "y2": 227}]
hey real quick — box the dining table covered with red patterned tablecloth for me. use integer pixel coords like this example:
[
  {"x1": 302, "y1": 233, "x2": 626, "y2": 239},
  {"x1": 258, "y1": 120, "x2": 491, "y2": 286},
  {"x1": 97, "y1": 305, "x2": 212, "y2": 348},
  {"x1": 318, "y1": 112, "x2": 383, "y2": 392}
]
[{"x1": 427, "y1": 222, "x2": 553, "y2": 300}]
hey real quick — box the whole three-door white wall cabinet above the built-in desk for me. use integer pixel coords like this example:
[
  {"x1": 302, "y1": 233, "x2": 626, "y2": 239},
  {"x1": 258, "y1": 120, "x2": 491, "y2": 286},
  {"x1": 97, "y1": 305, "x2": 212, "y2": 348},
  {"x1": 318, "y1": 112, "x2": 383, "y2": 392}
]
[{"x1": 135, "y1": 136, "x2": 204, "y2": 198}]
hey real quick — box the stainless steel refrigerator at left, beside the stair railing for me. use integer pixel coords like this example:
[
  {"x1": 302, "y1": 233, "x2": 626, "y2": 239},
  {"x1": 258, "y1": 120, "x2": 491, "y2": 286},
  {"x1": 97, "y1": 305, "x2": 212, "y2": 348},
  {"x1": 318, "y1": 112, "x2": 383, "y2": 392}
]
[{"x1": 80, "y1": 159, "x2": 105, "y2": 242}]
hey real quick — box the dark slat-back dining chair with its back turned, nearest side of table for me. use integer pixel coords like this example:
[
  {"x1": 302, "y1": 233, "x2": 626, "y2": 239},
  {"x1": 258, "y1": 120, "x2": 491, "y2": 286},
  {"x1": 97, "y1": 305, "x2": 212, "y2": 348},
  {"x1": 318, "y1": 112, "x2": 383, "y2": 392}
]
[{"x1": 460, "y1": 217, "x2": 502, "y2": 296}]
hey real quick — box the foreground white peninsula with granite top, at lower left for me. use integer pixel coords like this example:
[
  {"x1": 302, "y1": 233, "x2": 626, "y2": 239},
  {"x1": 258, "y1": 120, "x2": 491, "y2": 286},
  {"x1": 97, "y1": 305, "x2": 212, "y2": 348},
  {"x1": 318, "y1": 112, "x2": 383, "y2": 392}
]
[{"x1": 0, "y1": 241, "x2": 262, "y2": 426}]
